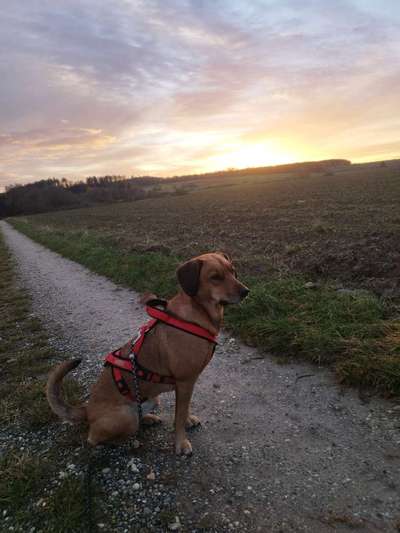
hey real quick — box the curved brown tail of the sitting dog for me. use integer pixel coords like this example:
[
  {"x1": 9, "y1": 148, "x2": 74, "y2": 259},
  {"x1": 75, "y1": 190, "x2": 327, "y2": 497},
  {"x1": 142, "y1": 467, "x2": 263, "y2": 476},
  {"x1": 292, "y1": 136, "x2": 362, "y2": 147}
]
[{"x1": 46, "y1": 359, "x2": 87, "y2": 423}]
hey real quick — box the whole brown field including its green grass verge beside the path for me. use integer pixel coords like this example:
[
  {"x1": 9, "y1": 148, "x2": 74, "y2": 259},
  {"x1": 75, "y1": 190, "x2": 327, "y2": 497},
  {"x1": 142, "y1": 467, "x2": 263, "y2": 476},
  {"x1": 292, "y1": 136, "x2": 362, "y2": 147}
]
[{"x1": 12, "y1": 168, "x2": 400, "y2": 394}]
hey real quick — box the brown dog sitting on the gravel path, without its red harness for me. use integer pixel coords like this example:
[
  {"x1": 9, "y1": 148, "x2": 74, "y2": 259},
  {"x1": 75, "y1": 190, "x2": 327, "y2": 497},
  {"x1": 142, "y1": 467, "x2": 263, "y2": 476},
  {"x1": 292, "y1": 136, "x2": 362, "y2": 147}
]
[{"x1": 47, "y1": 253, "x2": 249, "y2": 455}]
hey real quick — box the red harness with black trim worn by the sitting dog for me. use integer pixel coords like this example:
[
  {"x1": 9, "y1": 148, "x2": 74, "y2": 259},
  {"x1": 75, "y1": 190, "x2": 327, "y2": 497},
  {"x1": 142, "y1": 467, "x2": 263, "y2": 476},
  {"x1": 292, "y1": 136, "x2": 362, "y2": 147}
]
[{"x1": 104, "y1": 300, "x2": 217, "y2": 402}]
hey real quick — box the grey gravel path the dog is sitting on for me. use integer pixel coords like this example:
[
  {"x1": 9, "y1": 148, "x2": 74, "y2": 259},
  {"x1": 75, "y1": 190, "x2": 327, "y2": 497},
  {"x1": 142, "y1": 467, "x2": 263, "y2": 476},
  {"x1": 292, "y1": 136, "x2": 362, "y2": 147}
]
[{"x1": 1, "y1": 218, "x2": 400, "y2": 532}]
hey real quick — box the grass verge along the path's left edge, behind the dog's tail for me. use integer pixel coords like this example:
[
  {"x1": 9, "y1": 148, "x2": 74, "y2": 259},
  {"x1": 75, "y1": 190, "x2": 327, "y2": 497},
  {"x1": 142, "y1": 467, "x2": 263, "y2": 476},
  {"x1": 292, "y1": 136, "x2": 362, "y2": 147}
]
[{"x1": 0, "y1": 235, "x2": 97, "y2": 533}]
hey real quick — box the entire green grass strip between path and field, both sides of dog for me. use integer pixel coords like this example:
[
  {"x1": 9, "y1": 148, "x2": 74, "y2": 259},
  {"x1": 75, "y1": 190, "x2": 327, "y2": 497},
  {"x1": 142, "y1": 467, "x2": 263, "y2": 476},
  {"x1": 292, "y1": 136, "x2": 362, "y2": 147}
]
[{"x1": 11, "y1": 219, "x2": 400, "y2": 396}]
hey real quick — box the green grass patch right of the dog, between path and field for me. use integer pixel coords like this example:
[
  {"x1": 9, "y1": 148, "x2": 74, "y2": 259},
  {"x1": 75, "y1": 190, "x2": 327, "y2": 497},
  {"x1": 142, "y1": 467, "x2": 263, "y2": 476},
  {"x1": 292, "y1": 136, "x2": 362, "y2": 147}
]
[{"x1": 225, "y1": 278, "x2": 400, "y2": 396}]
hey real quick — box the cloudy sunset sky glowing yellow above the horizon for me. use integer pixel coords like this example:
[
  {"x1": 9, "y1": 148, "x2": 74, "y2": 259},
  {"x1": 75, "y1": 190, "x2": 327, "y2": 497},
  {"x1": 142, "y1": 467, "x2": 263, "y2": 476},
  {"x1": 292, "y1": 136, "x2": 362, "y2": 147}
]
[{"x1": 0, "y1": 0, "x2": 400, "y2": 188}]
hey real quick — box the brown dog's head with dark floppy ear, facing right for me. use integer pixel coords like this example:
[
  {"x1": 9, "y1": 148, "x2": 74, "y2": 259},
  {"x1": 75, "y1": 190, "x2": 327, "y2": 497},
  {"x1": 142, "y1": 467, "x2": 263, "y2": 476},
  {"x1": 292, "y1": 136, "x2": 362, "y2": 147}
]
[{"x1": 177, "y1": 252, "x2": 250, "y2": 305}]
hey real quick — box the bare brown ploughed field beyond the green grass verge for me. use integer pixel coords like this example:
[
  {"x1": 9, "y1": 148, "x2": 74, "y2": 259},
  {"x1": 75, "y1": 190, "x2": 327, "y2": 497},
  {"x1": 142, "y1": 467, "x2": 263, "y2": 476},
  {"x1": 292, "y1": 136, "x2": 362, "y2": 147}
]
[{"x1": 13, "y1": 168, "x2": 400, "y2": 297}]
